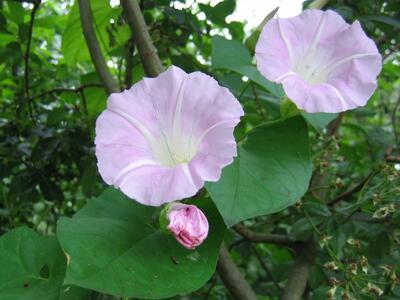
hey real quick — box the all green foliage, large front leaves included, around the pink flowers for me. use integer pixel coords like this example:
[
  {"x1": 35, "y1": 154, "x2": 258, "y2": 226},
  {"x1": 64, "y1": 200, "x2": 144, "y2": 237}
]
[{"x1": 0, "y1": 0, "x2": 400, "y2": 300}]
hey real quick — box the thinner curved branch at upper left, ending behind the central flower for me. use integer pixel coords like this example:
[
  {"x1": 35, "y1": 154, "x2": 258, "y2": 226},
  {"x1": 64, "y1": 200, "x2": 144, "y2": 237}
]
[{"x1": 78, "y1": 0, "x2": 119, "y2": 94}]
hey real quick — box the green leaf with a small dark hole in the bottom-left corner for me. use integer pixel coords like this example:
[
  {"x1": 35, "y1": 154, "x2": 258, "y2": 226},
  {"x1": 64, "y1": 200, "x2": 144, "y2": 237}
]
[{"x1": 0, "y1": 227, "x2": 66, "y2": 300}]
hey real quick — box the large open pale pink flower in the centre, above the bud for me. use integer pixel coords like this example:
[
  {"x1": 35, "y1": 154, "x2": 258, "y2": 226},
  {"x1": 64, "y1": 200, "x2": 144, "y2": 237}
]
[{"x1": 95, "y1": 66, "x2": 243, "y2": 206}]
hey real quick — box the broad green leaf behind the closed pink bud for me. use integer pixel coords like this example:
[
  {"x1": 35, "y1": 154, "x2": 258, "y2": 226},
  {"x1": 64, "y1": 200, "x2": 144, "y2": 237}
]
[{"x1": 57, "y1": 189, "x2": 225, "y2": 298}]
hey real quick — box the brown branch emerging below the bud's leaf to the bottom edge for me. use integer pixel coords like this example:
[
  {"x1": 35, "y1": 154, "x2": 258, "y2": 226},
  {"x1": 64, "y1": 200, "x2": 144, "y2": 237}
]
[{"x1": 217, "y1": 244, "x2": 257, "y2": 300}]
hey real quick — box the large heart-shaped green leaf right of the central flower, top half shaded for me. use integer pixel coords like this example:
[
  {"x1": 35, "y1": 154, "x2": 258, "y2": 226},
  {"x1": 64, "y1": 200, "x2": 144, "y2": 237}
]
[{"x1": 206, "y1": 117, "x2": 311, "y2": 226}]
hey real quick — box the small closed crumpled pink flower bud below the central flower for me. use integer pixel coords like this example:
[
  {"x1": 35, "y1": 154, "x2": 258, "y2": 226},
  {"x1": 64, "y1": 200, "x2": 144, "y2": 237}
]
[{"x1": 167, "y1": 203, "x2": 208, "y2": 249}]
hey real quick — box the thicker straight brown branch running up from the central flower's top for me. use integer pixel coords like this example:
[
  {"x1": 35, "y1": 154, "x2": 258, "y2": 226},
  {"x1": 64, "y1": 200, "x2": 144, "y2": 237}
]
[{"x1": 121, "y1": 0, "x2": 164, "y2": 77}]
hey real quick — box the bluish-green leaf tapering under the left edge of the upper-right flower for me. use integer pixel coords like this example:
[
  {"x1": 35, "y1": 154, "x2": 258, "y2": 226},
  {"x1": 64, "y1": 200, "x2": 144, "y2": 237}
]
[{"x1": 211, "y1": 36, "x2": 283, "y2": 97}]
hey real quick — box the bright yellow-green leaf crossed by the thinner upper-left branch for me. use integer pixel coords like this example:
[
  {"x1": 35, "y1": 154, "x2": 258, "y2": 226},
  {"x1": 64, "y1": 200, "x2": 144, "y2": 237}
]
[{"x1": 61, "y1": 0, "x2": 120, "y2": 66}]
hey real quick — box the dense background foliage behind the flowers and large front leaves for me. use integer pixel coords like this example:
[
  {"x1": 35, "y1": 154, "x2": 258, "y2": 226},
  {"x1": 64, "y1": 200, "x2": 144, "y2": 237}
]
[{"x1": 0, "y1": 0, "x2": 400, "y2": 300}]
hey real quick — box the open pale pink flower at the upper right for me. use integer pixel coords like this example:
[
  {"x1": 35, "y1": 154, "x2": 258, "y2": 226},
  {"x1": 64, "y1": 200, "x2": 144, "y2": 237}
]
[{"x1": 256, "y1": 9, "x2": 382, "y2": 113}]
